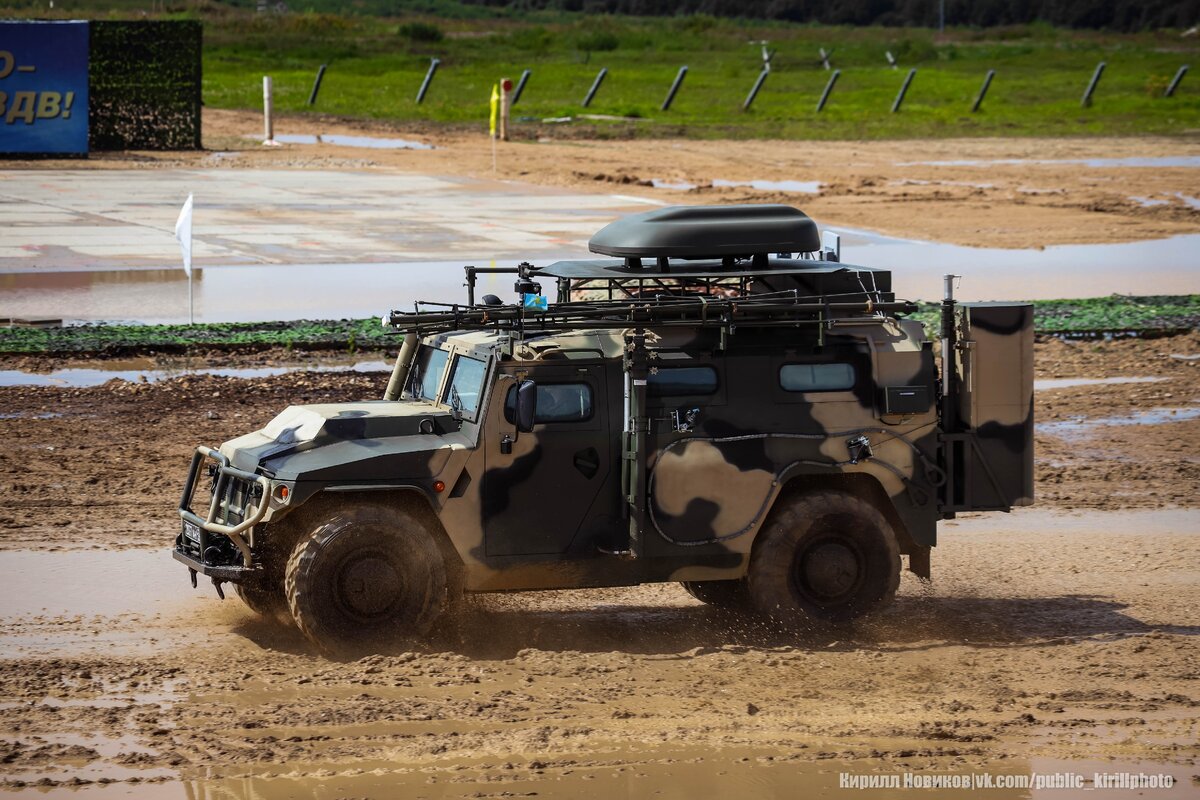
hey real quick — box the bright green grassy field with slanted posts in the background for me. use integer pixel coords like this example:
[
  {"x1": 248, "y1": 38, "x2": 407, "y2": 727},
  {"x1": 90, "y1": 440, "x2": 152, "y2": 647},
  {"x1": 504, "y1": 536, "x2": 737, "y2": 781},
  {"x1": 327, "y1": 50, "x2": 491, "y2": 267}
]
[{"x1": 7, "y1": 0, "x2": 1200, "y2": 139}]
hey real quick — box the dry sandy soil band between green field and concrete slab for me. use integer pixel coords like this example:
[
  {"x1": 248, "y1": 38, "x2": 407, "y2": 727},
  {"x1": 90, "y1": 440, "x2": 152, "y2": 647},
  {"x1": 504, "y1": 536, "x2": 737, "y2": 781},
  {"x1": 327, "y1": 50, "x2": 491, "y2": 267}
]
[{"x1": 0, "y1": 109, "x2": 1200, "y2": 248}]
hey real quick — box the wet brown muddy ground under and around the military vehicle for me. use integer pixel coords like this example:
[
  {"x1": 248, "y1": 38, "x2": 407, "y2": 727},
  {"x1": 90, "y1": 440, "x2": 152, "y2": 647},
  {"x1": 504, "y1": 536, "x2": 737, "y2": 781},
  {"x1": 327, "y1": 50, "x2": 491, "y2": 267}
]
[{"x1": 0, "y1": 333, "x2": 1200, "y2": 800}]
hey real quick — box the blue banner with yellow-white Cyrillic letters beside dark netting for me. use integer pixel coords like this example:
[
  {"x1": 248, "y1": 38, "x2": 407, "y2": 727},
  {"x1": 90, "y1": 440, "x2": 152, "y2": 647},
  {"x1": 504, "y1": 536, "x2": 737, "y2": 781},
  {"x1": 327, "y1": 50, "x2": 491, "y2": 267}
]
[{"x1": 0, "y1": 22, "x2": 88, "y2": 154}]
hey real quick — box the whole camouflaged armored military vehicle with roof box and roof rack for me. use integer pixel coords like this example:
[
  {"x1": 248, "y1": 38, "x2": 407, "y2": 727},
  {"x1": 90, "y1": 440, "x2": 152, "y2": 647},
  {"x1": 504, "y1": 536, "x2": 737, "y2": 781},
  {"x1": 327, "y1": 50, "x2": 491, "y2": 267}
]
[{"x1": 174, "y1": 205, "x2": 1033, "y2": 650}]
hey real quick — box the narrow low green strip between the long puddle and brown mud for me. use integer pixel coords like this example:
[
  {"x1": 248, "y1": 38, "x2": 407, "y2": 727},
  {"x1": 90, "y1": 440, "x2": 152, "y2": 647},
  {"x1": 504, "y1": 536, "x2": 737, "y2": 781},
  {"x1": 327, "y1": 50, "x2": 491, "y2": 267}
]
[{"x1": 0, "y1": 295, "x2": 1200, "y2": 355}]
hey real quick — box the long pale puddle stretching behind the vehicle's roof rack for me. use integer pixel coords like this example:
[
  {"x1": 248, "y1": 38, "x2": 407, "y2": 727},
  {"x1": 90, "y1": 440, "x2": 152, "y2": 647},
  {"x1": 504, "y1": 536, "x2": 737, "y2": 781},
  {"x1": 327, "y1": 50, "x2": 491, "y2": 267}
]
[{"x1": 0, "y1": 228, "x2": 1200, "y2": 323}]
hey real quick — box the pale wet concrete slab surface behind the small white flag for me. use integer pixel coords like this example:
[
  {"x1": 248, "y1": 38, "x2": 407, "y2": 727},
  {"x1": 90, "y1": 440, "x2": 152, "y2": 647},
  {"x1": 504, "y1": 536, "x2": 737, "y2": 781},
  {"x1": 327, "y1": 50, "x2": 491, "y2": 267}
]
[{"x1": 0, "y1": 169, "x2": 654, "y2": 272}]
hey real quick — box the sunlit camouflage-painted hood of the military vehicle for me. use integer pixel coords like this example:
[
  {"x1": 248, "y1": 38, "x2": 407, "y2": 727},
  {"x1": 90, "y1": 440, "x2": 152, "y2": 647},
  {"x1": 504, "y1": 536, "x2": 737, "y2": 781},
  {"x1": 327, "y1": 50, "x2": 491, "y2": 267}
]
[{"x1": 221, "y1": 401, "x2": 458, "y2": 471}]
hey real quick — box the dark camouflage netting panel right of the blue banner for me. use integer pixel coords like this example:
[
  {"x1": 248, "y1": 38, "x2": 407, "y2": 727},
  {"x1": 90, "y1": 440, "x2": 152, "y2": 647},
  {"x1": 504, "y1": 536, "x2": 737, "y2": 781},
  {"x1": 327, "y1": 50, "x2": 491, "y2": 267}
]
[{"x1": 88, "y1": 22, "x2": 203, "y2": 150}]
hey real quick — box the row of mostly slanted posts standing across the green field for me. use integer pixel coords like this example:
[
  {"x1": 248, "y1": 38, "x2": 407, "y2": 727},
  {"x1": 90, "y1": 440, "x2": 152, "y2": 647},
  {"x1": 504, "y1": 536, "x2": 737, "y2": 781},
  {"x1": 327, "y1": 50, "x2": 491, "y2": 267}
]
[{"x1": 285, "y1": 58, "x2": 1189, "y2": 119}]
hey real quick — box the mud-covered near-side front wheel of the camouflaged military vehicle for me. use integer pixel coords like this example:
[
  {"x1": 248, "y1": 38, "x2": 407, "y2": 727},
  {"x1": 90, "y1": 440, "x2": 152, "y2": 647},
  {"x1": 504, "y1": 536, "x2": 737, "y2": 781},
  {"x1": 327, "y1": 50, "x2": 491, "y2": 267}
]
[{"x1": 284, "y1": 504, "x2": 448, "y2": 655}]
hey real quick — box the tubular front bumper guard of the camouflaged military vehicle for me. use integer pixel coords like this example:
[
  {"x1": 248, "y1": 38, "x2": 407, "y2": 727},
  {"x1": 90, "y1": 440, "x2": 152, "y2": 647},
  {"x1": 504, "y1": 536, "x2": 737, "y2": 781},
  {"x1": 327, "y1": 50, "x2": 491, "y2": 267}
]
[{"x1": 174, "y1": 445, "x2": 271, "y2": 579}]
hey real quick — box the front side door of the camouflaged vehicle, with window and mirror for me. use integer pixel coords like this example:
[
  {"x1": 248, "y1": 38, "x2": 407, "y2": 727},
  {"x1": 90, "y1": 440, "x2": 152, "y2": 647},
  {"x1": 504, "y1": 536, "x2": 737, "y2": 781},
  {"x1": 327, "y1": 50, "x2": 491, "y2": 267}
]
[{"x1": 481, "y1": 363, "x2": 612, "y2": 557}]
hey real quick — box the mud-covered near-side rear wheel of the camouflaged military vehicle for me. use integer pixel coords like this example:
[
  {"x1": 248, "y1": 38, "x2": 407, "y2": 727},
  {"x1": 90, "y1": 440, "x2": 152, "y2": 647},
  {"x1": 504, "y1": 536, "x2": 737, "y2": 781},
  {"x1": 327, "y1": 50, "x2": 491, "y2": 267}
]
[{"x1": 746, "y1": 491, "x2": 900, "y2": 627}]
